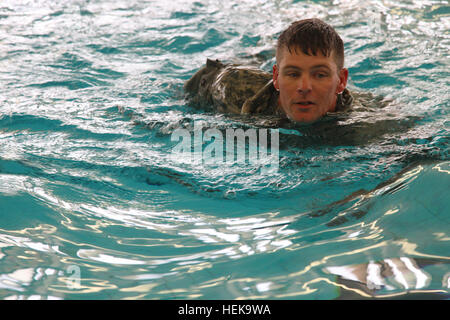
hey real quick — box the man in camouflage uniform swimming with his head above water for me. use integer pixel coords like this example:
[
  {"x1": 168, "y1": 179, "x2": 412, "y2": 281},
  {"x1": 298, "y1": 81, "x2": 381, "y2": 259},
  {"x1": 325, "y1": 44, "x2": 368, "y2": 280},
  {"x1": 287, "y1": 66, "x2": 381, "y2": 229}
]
[{"x1": 185, "y1": 19, "x2": 353, "y2": 122}]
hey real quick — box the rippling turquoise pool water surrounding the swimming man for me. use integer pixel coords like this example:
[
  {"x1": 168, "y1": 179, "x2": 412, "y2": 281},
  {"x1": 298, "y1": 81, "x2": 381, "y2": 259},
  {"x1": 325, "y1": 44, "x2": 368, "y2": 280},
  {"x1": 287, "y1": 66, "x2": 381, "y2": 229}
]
[{"x1": 0, "y1": 0, "x2": 450, "y2": 299}]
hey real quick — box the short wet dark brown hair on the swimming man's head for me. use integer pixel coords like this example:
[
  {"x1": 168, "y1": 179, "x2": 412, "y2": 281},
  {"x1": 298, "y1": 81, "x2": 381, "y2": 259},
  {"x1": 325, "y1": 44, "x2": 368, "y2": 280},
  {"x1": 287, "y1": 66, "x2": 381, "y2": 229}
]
[{"x1": 277, "y1": 19, "x2": 344, "y2": 71}]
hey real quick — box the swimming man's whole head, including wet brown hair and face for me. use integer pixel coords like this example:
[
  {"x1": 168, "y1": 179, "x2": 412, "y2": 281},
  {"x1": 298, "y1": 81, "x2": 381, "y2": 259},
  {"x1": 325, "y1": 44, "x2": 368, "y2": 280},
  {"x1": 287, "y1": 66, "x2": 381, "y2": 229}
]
[{"x1": 273, "y1": 19, "x2": 348, "y2": 122}]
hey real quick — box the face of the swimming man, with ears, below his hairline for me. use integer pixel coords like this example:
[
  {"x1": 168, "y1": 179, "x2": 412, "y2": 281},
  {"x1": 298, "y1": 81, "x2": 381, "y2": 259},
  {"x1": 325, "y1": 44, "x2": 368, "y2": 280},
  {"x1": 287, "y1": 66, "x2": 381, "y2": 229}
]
[{"x1": 273, "y1": 48, "x2": 348, "y2": 122}]
